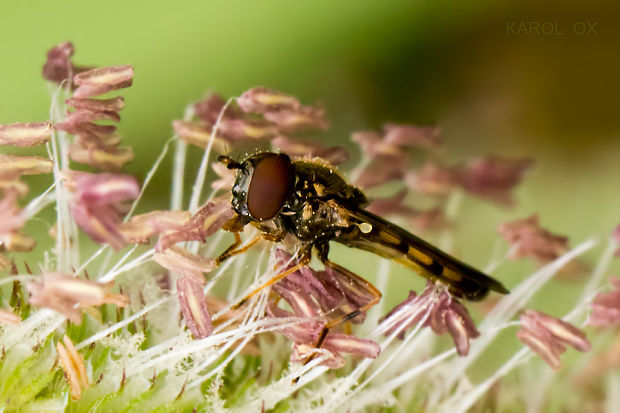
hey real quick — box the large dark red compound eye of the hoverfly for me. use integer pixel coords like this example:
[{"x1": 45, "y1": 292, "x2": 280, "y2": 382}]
[{"x1": 247, "y1": 153, "x2": 295, "y2": 221}]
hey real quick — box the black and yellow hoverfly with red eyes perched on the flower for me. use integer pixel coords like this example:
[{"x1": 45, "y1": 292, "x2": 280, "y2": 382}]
[{"x1": 217, "y1": 152, "x2": 508, "y2": 347}]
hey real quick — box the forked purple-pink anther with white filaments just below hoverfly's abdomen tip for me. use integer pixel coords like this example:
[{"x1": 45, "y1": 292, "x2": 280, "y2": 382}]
[{"x1": 380, "y1": 281, "x2": 480, "y2": 356}]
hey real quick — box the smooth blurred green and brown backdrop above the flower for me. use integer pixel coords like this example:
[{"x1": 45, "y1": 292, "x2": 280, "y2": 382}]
[{"x1": 0, "y1": 0, "x2": 620, "y2": 306}]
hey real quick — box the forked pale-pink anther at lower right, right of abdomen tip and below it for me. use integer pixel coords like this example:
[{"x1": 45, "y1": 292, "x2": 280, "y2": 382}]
[{"x1": 517, "y1": 310, "x2": 591, "y2": 370}]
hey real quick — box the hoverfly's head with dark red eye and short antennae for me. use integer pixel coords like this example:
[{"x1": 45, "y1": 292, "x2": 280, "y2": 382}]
[{"x1": 218, "y1": 152, "x2": 295, "y2": 221}]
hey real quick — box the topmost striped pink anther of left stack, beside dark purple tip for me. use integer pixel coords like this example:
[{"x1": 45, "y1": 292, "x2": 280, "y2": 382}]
[{"x1": 73, "y1": 65, "x2": 134, "y2": 98}]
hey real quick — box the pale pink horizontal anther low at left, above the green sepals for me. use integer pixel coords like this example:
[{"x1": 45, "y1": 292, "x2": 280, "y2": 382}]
[{"x1": 26, "y1": 273, "x2": 129, "y2": 324}]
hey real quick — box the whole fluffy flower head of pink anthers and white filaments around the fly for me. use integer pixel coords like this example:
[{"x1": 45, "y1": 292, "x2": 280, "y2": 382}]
[{"x1": 0, "y1": 43, "x2": 620, "y2": 411}]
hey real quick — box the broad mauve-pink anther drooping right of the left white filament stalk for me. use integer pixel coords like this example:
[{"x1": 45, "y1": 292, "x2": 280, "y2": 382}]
[{"x1": 65, "y1": 171, "x2": 140, "y2": 249}]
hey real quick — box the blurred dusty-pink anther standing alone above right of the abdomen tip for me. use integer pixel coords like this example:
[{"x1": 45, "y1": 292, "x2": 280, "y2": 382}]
[{"x1": 497, "y1": 214, "x2": 569, "y2": 265}]
